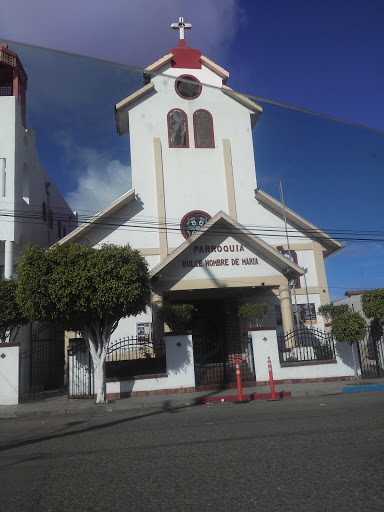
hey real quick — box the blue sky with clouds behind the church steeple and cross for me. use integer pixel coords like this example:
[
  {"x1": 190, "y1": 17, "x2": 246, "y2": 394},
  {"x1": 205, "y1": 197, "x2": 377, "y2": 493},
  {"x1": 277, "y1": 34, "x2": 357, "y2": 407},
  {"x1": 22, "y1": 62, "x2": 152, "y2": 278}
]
[{"x1": 0, "y1": 0, "x2": 384, "y2": 298}]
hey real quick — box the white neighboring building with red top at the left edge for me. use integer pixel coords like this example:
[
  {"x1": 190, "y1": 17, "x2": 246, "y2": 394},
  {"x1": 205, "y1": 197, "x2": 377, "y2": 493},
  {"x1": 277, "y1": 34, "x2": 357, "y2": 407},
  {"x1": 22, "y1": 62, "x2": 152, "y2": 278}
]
[{"x1": 0, "y1": 44, "x2": 77, "y2": 278}]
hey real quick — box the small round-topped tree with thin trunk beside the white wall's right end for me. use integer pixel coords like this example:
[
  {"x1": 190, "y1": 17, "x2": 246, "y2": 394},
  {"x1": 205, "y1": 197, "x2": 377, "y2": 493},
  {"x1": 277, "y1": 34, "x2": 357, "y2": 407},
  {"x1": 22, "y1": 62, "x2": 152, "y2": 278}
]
[{"x1": 332, "y1": 311, "x2": 367, "y2": 380}]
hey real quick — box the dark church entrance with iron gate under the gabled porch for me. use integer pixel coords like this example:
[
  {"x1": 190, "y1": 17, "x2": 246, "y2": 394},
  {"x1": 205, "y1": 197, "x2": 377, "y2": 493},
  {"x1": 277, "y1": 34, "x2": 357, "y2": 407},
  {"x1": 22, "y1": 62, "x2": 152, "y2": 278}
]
[{"x1": 192, "y1": 299, "x2": 255, "y2": 386}]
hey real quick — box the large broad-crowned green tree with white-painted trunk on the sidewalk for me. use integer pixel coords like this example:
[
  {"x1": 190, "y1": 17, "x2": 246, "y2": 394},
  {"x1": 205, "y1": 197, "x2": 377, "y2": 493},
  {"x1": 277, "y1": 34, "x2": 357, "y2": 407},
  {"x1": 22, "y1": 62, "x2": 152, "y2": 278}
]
[{"x1": 17, "y1": 244, "x2": 150, "y2": 403}]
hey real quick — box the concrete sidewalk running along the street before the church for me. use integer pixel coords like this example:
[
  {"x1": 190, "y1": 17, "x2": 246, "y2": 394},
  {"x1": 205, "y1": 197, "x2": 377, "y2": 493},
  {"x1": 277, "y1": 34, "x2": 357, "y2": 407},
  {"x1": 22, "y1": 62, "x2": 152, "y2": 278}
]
[{"x1": 0, "y1": 379, "x2": 384, "y2": 419}]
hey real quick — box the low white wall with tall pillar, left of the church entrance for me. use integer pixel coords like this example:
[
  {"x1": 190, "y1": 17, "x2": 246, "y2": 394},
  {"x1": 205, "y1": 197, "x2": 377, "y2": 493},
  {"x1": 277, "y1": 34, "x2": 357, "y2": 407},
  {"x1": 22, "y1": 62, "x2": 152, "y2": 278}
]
[{"x1": 107, "y1": 334, "x2": 195, "y2": 394}]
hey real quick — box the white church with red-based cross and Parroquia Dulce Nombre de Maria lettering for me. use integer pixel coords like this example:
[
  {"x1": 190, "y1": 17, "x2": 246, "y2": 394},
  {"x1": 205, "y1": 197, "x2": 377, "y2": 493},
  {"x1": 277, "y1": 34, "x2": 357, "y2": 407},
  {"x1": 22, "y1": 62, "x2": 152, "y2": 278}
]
[{"x1": 59, "y1": 19, "x2": 360, "y2": 396}]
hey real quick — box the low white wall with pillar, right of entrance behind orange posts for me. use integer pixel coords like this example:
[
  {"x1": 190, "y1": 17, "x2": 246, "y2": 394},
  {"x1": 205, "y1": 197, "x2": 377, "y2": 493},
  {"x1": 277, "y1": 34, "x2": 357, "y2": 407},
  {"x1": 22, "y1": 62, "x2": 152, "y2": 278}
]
[{"x1": 250, "y1": 330, "x2": 360, "y2": 382}]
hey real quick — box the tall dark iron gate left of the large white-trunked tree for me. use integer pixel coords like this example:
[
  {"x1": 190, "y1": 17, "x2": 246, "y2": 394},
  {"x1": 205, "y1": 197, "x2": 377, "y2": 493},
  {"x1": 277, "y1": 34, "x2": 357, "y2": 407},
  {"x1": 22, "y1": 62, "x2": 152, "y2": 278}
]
[{"x1": 20, "y1": 324, "x2": 65, "y2": 402}]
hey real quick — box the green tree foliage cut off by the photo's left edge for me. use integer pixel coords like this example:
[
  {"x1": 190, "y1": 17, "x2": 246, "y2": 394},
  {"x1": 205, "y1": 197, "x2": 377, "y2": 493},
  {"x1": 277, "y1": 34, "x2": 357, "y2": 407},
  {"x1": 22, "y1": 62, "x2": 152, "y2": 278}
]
[{"x1": 0, "y1": 277, "x2": 28, "y2": 343}]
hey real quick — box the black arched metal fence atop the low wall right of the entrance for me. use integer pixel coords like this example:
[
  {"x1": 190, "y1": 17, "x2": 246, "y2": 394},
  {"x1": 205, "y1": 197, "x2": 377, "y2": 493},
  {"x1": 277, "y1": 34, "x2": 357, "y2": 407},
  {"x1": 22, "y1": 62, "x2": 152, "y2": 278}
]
[{"x1": 277, "y1": 327, "x2": 336, "y2": 364}]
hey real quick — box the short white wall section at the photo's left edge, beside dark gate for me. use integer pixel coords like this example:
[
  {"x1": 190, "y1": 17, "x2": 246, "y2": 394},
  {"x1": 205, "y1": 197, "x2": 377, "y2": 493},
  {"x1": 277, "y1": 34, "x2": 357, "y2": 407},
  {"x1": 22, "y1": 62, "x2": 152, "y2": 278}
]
[{"x1": 0, "y1": 343, "x2": 20, "y2": 405}]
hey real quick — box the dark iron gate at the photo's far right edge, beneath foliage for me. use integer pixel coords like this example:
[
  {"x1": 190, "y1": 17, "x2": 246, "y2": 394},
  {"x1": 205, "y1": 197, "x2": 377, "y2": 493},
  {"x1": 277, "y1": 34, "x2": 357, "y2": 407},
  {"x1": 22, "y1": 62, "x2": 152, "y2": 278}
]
[{"x1": 358, "y1": 325, "x2": 384, "y2": 379}]
